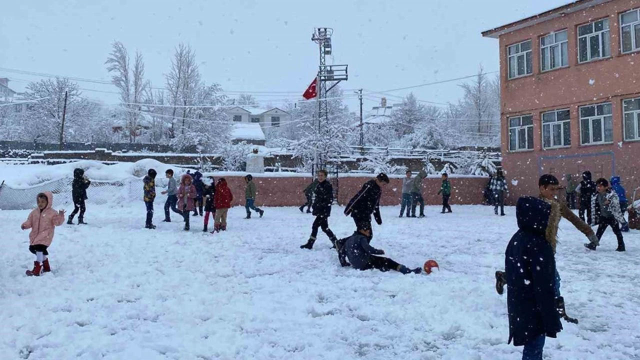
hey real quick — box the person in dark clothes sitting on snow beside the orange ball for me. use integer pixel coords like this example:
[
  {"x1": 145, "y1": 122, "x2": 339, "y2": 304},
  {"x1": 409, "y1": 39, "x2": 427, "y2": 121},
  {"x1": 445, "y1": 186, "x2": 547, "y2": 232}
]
[{"x1": 338, "y1": 229, "x2": 422, "y2": 274}]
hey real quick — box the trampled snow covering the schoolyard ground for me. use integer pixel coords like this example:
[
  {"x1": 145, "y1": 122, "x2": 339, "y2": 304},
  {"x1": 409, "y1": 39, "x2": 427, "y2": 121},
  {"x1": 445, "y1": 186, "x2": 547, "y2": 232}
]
[{"x1": 0, "y1": 204, "x2": 640, "y2": 360}]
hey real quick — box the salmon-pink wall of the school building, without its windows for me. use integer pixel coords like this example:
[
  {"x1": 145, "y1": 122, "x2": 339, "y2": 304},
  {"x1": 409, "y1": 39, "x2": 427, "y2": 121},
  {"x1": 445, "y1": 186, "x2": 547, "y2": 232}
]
[{"x1": 499, "y1": 0, "x2": 640, "y2": 201}]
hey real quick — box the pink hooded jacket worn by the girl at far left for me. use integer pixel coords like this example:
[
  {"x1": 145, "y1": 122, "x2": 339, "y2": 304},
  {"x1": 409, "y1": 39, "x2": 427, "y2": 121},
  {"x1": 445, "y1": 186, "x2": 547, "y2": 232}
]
[{"x1": 22, "y1": 191, "x2": 64, "y2": 246}]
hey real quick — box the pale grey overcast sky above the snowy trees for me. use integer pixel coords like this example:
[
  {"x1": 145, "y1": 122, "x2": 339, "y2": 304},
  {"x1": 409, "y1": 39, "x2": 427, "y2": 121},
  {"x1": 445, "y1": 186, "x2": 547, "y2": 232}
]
[{"x1": 0, "y1": 0, "x2": 568, "y2": 111}]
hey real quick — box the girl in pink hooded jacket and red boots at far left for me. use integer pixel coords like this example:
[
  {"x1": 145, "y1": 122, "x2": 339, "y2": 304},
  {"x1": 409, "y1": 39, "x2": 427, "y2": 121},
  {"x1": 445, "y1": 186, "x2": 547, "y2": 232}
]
[{"x1": 21, "y1": 191, "x2": 64, "y2": 276}]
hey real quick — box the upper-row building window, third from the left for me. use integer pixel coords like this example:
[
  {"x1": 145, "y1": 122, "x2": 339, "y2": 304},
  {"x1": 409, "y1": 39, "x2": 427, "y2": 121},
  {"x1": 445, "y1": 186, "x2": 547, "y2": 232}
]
[{"x1": 578, "y1": 19, "x2": 611, "y2": 63}]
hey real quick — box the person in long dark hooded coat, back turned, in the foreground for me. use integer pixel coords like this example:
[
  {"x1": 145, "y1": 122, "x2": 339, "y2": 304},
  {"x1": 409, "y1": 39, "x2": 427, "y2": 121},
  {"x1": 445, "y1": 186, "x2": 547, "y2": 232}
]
[{"x1": 505, "y1": 197, "x2": 562, "y2": 360}]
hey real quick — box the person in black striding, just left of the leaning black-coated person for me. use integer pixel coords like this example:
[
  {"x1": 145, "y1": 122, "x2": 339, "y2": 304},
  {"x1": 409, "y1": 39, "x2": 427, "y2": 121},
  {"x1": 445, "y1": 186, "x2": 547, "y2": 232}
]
[{"x1": 300, "y1": 170, "x2": 337, "y2": 250}]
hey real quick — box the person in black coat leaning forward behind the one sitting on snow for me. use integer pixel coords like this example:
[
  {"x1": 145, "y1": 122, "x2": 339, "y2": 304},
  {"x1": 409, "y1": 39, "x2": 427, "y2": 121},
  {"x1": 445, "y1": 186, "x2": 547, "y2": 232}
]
[{"x1": 344, "y1": 173, "x2": 389, "y2": 241}]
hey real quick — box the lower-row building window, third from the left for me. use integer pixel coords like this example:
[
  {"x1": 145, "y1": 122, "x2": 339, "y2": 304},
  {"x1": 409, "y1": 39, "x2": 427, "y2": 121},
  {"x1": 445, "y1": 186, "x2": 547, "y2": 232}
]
[{"x1": 580, "y1": 103, "x2": 613, "y2": 145}]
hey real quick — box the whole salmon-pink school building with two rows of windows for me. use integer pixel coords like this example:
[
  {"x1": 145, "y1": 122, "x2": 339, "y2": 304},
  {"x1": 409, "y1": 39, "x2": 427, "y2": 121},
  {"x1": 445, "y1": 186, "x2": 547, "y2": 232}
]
[{"x1": 482, "y1": 0, "x2": 640, "y2": 203}]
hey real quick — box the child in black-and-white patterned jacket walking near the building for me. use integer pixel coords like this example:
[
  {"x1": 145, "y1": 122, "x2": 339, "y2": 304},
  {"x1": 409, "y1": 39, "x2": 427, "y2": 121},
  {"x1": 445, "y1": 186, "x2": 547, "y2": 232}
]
[{"x1": 584, "y1": 178, "x2": 628, "y2": 251}]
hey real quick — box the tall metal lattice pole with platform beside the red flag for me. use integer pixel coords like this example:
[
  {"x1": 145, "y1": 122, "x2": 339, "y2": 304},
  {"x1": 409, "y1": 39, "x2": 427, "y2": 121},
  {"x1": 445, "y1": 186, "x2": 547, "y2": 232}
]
[{"x1": 311, "y1": 28, "x2": 349, "y2": 170}]
